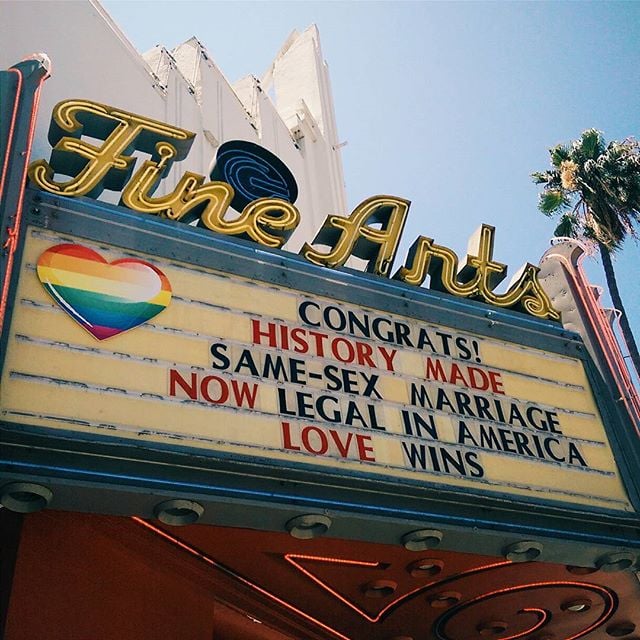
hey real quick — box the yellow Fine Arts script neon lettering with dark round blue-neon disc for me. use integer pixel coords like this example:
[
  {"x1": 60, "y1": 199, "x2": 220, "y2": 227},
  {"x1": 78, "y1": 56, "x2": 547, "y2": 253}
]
[{"x1": 29, "y1": 100, "x2": 560, "y2": 320}]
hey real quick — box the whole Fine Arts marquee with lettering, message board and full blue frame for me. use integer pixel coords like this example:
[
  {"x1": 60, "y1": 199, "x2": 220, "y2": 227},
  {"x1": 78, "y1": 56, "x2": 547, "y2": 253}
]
[{"x1": 0, "y1": 91, "x2": 640, "y2": 544}]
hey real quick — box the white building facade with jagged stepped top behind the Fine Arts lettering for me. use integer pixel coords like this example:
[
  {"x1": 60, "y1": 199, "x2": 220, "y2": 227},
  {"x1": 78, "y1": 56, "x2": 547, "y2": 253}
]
[{"x1": 0, "y1": 0, "x2": 347, "y2": 251}]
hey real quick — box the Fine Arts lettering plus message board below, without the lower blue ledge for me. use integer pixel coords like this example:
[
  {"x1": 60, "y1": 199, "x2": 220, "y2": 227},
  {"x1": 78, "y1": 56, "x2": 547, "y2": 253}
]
[{"x1": 0, "y1": 101, "x2": 633, "y2": 512}]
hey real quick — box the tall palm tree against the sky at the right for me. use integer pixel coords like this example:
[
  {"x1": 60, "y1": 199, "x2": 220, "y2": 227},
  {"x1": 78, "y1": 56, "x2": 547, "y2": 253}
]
[{"x1": 532, "y1": 129, "x2": 640, "y2": 375}]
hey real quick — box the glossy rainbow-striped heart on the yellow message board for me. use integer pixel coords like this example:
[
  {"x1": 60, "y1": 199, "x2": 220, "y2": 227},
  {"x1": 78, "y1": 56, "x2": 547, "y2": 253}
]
[{"x1": 37, "y1": 244, "x2": 171, "y2": 340}]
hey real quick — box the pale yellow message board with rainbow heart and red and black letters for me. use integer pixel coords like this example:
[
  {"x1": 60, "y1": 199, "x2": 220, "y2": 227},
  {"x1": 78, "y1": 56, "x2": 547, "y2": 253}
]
[{"x1": 1, "y1": 222, "x2": 631, "y2": 511}]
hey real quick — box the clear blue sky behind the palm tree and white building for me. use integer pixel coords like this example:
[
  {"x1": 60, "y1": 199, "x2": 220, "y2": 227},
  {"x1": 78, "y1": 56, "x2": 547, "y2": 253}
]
[{"x1": 103, "y1": 0, "x2": 640, "y2": 358}]
